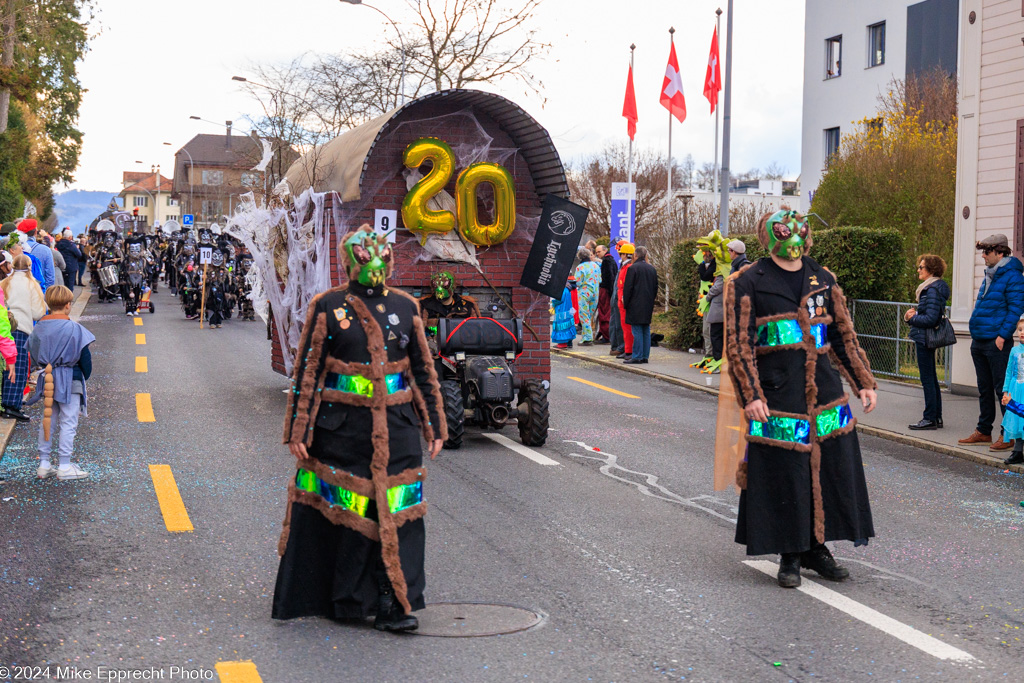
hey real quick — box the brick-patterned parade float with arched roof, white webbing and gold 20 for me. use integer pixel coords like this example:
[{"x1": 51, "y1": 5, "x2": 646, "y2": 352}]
[{"x1": 226, "y1": 90, "x2": 587, "y2": 444}]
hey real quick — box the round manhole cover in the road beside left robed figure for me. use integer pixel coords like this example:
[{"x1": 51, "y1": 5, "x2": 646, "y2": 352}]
[{"x1": 414, "y1": 602, "x2": 544, "y2": 638}]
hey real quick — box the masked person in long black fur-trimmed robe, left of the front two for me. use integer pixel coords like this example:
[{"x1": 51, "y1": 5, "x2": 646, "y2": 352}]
[{"x1": 273, "y1": 225, "x2": 447, "y2": 631}]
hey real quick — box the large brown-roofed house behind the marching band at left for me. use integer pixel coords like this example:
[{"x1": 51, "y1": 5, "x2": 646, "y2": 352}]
[{"x1": 174, "y1": 121, "x2": 299, "y2": 226}]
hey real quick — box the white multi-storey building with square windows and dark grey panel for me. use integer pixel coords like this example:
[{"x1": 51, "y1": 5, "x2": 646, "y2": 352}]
[{"x1": 801, "y1": 0, "x2": 962, "y2": 211}]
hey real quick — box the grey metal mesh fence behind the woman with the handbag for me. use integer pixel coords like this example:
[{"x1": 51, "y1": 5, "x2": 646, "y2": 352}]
[{"x1": 850, "y1": 299, "x2": 952, "y2": 387}]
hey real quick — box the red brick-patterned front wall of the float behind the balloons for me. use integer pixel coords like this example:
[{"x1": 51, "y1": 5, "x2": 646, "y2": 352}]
[{"x1": 272, "y1": 91, "x2": 568, "y2": 380}]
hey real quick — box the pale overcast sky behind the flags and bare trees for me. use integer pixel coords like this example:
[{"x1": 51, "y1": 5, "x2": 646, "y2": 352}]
[{"x1": 70, "y1": 0, "x2": 804, "y2": 190}]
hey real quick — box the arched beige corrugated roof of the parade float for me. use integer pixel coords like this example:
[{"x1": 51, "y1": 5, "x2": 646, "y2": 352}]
[{"x1": 285, "y1": 89, "x2": 569, "y2": 202}]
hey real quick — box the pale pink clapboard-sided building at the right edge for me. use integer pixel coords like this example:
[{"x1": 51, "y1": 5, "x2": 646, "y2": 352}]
[{"x1": 949, "y1": 0, "x2": 1024, "y2": 392}]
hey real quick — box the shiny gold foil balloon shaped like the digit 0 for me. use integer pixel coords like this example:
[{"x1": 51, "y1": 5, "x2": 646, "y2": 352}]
[{"x1": 455, "y1": 162, "x2": 515, "y2": 247}]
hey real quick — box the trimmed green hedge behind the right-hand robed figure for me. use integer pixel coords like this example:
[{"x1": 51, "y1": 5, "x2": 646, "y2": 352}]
[{"x1": 666, "y1": 227, "x2": 909, "y2": 348}]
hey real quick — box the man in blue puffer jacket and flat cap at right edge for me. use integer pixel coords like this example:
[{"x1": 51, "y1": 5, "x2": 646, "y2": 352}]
[{"x1": 959, "y1": 234, "x2": 1024, "y2": 451}]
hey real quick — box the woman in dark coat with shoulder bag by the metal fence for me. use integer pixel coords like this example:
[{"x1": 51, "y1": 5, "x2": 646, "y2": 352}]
[{"x1": 903, "y1": 254, "x2": 949, "y2": 429}]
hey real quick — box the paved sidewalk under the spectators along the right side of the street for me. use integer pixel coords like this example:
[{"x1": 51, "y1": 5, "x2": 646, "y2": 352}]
[{"x1": 551, "y1": 342, "x2": 1024, "y2": 474}]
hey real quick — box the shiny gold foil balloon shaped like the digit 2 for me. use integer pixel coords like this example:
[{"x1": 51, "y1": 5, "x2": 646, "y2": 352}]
[{"x1": 401, "y1": 137, "x2": 455, "y2": 244}]
